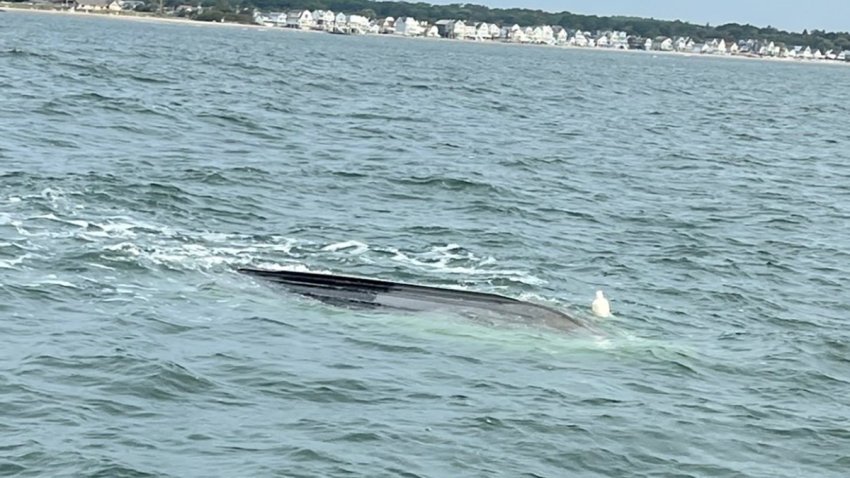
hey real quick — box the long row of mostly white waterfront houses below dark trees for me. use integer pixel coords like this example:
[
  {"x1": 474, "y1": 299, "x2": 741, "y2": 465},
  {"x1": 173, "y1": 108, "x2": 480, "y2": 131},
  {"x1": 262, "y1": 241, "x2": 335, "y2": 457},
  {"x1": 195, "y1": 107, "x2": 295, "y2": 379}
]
[{"x1": 254, "y1": 10, "x2": 850, "y2": 61}]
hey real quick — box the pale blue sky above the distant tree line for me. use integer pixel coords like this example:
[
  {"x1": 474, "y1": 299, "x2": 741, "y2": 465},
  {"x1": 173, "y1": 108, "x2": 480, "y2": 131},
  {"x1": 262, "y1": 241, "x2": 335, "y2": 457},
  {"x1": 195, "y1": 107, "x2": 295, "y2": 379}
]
[{"x1": 426, "y1": 0, "x2": 850, "y2": 32}]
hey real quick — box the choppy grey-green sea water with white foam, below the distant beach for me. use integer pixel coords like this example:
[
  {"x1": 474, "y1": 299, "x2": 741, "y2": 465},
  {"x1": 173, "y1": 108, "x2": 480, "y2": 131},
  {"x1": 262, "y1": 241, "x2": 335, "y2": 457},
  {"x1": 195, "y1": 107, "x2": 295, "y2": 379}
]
[{"x1": 0, "y1": 12, "x2": 850, "y2": 478}]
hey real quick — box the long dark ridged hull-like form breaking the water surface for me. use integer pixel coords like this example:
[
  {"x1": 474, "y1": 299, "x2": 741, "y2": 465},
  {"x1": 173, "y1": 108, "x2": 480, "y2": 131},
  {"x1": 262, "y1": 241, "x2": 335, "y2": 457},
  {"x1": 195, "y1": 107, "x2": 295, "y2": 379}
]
[{"x1": 239, "y1": 269, "x2": 580, "y2": 329}]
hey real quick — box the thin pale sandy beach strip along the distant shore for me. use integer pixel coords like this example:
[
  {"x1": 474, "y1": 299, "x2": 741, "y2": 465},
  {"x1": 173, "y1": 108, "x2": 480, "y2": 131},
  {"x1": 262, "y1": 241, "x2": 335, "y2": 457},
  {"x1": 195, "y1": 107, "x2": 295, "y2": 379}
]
[{"x1": 0, "y1": 2, "x2": 850, "y2": 66}]
